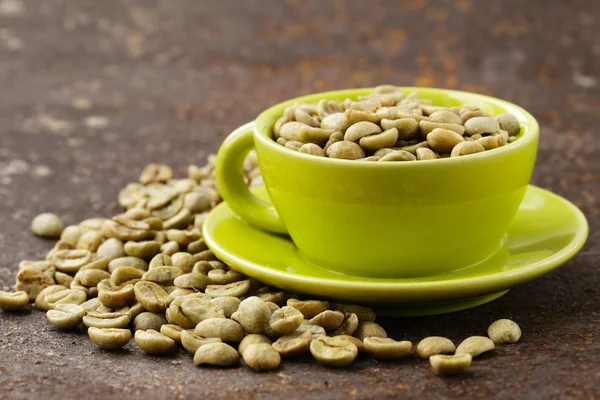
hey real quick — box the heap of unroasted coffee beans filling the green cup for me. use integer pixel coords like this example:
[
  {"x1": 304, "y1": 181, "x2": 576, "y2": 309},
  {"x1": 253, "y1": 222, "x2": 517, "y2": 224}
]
[{"x1": 273, "y1": 85, "x2": 521, "y2": 162}]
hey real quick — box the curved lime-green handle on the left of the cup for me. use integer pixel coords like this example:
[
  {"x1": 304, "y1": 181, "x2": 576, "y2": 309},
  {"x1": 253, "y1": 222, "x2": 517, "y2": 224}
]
[{"x1": 216, "y1": 122, "x2": 287, "y2": 234}]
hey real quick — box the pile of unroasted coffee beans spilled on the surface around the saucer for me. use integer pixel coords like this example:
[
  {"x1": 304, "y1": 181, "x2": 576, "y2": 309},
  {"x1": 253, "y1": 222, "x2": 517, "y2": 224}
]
[{"x1": 0, "y1": 153, "x2": 521, "y2": 375}]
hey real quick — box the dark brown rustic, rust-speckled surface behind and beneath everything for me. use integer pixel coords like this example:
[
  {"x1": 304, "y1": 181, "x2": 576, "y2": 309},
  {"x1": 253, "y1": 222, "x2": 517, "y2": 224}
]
[{"x1": 0, "y1": 0, "x2": 600, "y2": 399}]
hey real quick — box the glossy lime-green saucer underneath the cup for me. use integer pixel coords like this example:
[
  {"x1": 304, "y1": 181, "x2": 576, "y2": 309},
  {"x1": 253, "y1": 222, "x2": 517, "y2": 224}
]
[{"x1": 203, "y1": 186, "x2": 588, "y2": 316}]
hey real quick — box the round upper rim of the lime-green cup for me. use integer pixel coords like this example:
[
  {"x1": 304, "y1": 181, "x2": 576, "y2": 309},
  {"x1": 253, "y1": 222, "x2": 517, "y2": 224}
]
[{"x1": 254, "y1": 86, "x2": 540, "y2": 168}]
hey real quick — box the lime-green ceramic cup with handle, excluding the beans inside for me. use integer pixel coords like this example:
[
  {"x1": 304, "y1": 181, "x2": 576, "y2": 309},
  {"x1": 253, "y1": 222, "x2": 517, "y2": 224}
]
[{"x1": 216, "y1": 88, "x2": 539, "y2": 278}]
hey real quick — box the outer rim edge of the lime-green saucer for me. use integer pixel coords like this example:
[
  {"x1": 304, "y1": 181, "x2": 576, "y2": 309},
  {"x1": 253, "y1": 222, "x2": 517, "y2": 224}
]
[{"x1": 202, "y1": 185, "x2": 589, "y2": 300}]
